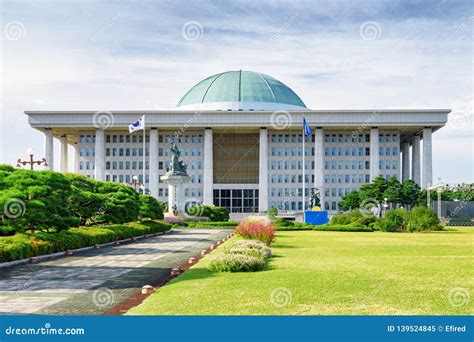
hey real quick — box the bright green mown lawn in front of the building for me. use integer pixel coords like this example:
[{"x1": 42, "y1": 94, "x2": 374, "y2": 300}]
[{"x1": 129, "y1": 228, "x2": 474, "y2": 315}]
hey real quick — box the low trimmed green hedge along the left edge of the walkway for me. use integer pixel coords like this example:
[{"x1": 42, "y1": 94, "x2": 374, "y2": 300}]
[{"x1": 0, "y1": 220, "x2": 171, "y2": 262}]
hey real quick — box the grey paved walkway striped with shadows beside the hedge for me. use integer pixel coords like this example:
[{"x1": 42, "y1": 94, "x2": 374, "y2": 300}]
[{"x1": 0, "y1": 229, "x2": 229, "y2": 315}]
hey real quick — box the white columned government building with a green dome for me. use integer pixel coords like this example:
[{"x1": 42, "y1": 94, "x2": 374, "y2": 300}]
[{"x1": 25, "y1": 71, "x2": 450, "y2": 213}]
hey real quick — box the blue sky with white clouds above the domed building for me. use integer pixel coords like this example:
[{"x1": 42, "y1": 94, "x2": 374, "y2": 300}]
[{"x1": 0, "y1": 0, "x2": 474, "y2": 182}]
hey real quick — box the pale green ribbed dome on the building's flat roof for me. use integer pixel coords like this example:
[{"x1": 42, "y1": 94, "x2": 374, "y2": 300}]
[{"x1": 176, "y1": 70, "x2": 307, "y2": 111}]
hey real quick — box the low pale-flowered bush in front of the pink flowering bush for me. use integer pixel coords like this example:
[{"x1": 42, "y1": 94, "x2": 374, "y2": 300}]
[{"x1": 209, "y1": 254, "x2": 265, "y2": 272}]
